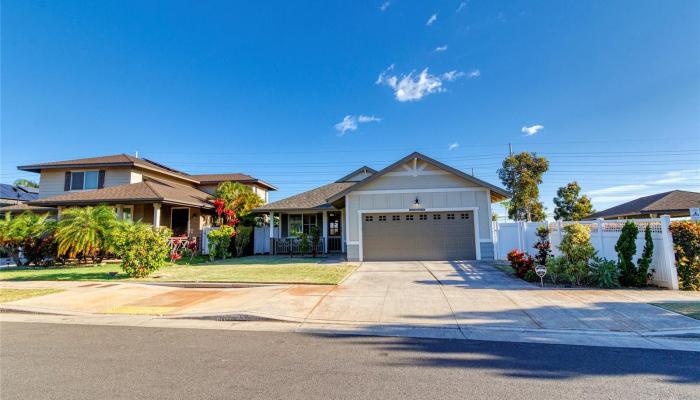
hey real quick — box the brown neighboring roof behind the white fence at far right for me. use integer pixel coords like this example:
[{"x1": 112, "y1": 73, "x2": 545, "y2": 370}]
[{"x1": 586, "y1": 190, "x2": 700, "y2": 219}]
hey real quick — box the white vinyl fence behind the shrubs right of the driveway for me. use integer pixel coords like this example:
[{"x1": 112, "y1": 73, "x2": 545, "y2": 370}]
[{"x1": 494, "y1": 215, "x2": 678, "y2": 290}]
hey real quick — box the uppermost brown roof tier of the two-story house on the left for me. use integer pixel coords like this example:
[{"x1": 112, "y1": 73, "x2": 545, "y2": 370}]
[{"x1": 17, "y1": 154, "x2": 199, "y2": 183}]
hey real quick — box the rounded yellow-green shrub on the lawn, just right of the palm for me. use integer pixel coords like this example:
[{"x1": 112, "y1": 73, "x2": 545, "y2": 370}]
[{"x1": 110, "y1": 221, "x2": 171, "y2": 278}]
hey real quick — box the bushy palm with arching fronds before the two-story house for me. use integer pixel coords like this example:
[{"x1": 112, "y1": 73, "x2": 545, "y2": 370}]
[{"x1": 56, "y1": 206, "x2": 117, "y2": 262}]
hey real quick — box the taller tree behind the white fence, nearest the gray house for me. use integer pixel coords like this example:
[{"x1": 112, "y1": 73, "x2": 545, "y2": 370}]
[{"x1": 498, "y1": 152, "x2": 549, "y2": 221}]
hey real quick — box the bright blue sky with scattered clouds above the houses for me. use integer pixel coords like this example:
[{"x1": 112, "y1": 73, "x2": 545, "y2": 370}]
[{"x1": 0, "y1": 0, "x2": 700, "y2": 219}]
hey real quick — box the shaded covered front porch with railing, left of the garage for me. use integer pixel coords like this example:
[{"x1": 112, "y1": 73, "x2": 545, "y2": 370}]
[{"x1": 260, "y1": 209, "x2": 345, "y2": 255}]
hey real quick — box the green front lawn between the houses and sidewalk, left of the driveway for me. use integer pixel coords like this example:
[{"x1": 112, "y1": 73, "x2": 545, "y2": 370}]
[{"x1": 0, "y1": 256, "x2": 356, "y2": 285}]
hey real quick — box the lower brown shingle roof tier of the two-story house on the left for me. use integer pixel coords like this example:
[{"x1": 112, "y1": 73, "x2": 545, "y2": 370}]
[{"x1": 30, "y1": 180, "x2": 214, "y2": 208}]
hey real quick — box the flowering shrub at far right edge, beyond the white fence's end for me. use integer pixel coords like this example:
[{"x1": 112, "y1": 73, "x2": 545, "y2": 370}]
[{"x1": 671, "y1": 221, "x2": 700, "y2": 290}]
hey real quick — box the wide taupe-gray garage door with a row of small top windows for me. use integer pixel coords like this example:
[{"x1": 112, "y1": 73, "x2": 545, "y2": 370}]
[{"x1": 362, "y1": 211, "x2": 476, "y2": 261}]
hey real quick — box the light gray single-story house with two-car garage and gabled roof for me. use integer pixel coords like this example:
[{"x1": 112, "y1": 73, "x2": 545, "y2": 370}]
[{"x1": 255, "y1": 152, "x2": 510, "y2": 261}]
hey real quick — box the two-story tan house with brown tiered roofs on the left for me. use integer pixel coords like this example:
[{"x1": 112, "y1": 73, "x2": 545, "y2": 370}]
[{"x1": 11, "y1": 154, "x2": 277, "y2": 237}]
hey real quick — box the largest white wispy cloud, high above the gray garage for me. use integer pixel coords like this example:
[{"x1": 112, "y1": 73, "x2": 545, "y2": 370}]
[{"x1": 375, "y1": 64, "x2": 478, "y2": 102}]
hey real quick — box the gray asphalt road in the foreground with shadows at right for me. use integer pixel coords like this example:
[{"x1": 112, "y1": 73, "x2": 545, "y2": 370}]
[{"x1": 0, "y1": 322, "x2": 700, "y2": 400}]
